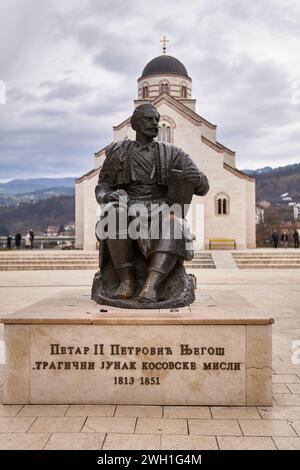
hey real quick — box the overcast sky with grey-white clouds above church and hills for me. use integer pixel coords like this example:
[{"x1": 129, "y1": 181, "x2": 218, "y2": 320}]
[{"x1": 0, "y1": 0, "x2": 300, "y2": 181}]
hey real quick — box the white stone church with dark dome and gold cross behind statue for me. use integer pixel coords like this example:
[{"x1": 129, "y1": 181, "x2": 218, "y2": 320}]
[{"x1": 76, "y1": 45, "x2": 256, "y2": 250}]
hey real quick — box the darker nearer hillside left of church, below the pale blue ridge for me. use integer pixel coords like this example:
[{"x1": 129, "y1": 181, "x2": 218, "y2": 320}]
[{"x1": 0, "y1": 196, "x2": 75, "y2": 235}]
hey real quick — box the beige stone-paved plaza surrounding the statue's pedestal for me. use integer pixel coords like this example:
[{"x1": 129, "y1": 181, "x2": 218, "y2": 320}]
[{"x1": 0, "y1": 269, "x2": 300, "y2": 450}]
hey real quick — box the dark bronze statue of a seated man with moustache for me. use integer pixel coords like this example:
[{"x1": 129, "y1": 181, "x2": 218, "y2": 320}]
[{"x1": 92, "y1": 103, "x2": 209, "y2": 308}]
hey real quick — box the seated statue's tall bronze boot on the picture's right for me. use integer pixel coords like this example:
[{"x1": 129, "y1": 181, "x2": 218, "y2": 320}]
[{"x1": 138, "y1": 253, "x2": 177, "y2": 303}]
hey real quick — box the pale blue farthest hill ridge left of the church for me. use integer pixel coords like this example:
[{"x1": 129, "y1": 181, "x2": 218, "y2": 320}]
[{"x1": 0, "y1": 177, "x2": 75, "y2": 196}]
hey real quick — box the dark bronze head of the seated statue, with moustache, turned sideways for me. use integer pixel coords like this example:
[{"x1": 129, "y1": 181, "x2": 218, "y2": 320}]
[{"x1": 130, "y1": 103, "x2": 160, "y2": 139}]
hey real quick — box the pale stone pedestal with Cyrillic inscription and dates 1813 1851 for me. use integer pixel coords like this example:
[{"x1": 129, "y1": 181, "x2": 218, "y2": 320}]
[{"x1": 2, "y1": 288, "x2": 273, "y2": 406}]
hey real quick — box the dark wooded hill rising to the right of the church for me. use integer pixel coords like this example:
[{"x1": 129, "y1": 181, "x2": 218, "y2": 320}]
[{"x1": 244, "y1": 163, "x2": 300, "y2": 204}]
